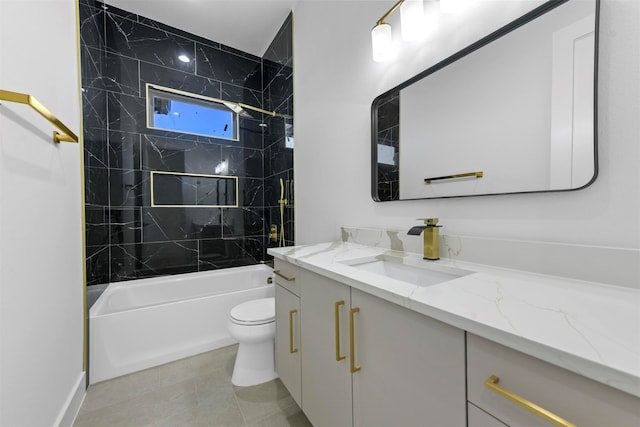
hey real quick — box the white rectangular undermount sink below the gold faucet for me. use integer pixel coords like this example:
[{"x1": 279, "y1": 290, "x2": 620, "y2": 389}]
[{"x1": 345, "y1": 255, "x2": 473, "y2": 286}]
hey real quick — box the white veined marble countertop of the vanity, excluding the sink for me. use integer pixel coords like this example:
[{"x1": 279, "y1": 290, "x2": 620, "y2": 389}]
[{"x1": 268, "y1": 242, "x2": 640, "y2": 397}]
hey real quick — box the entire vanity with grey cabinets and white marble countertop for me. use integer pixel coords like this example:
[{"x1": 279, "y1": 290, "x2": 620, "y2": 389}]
[{"x1": 269, "y1": 243, "x2": 640, "y2": 427}]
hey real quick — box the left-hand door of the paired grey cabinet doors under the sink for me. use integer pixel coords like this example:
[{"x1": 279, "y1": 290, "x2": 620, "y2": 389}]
[{"x1": 299, "y1": 270, "x2": 352, "y2": 427}]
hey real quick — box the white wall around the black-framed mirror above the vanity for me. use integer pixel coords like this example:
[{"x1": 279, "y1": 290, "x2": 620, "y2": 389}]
[{"x1": 294, "y1": 0, "x2": 640, "y2": 248}]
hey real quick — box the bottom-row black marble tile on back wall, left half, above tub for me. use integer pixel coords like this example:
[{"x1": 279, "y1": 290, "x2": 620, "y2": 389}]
[{"x1": 111, "y1": 240, "x2": 198, "y2": 282}]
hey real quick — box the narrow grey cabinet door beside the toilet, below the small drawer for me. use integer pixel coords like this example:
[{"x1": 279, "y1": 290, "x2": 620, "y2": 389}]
[{"x1": 276, "y1": 285, "x2": 302, "y2": 406}]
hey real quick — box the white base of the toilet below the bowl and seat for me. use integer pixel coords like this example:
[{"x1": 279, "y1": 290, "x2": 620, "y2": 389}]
[{"x1": 231, "y1": 339, "x2": 278, "y2": 387}]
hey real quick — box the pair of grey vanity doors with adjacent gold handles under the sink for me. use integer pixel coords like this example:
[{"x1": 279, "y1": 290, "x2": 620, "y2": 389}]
[{"x1": 299, "y1": 269, "x2": 466, "y2": 427}]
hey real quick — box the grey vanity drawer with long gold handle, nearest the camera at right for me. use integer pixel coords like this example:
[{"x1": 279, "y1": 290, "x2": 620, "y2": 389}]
[{"x1": 467, "y1": 334, "x2": 640, "y2": 427}]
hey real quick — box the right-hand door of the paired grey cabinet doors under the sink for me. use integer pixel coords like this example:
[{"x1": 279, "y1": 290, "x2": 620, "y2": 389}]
[{"x1": 351, "y1": 289, "x2": 467, "y2": 427}]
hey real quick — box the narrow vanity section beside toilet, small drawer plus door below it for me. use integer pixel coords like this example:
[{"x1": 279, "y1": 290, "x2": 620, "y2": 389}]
[{"x1": 275, "y1": 260, "x2": 302, "y2": 406}]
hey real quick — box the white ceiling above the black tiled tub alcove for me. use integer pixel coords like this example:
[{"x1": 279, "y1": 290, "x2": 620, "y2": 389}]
[{"x1": 105, "y1": 0, "x2": 299, "y2": 57}]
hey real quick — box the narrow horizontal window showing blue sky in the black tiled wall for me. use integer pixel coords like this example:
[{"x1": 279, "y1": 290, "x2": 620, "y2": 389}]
[{"x1": 147, "y1": 84, "x2": 239, "y2": 141}]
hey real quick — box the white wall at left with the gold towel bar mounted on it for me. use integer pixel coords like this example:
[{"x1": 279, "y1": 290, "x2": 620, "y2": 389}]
[{"x1": 0, "y1": 0, "x2": 84, "y2": 427}]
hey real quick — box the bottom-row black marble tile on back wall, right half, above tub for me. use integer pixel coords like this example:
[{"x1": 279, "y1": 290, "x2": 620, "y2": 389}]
[{"x1": 199, "y1": 237, "x2": 264, "y2": 270}]
